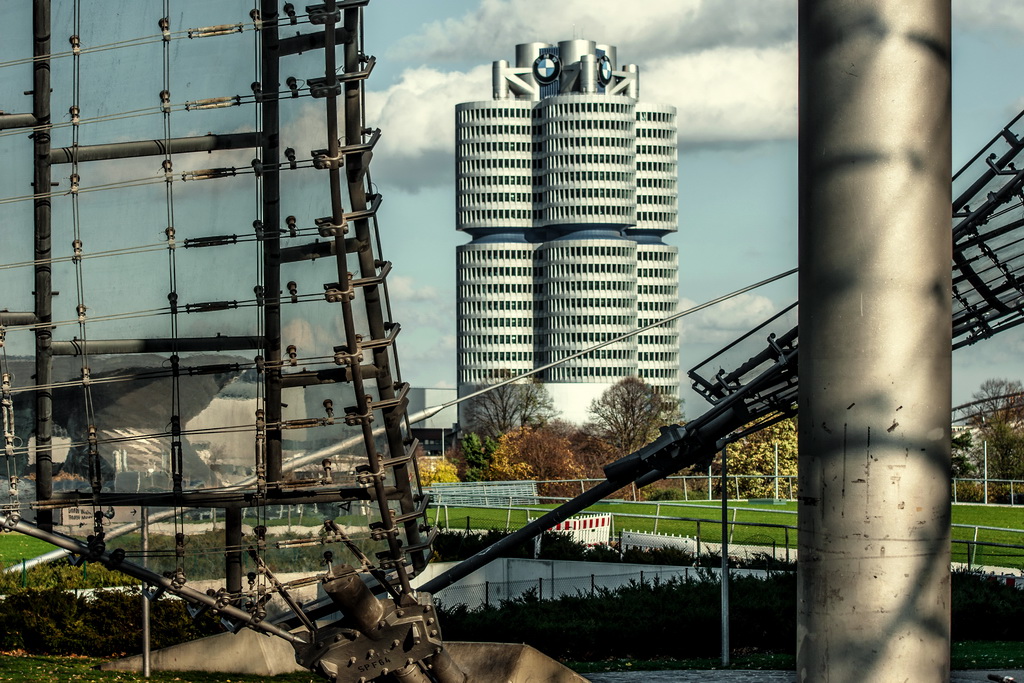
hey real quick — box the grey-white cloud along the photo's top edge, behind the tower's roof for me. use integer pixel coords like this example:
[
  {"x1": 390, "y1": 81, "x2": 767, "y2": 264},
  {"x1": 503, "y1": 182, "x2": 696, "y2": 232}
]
[{"x1": 387, "y1": 0, "x2": 797, "y2": 63}]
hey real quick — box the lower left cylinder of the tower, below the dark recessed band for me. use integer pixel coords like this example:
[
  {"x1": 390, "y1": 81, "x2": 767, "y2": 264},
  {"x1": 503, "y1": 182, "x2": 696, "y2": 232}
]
[{"x1": 456, "y1": 240, "x2": 535, "y2": 393}]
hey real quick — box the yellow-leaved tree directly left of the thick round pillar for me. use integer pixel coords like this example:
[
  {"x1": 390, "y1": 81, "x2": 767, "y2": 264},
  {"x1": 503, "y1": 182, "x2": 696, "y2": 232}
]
[{"x1": 728, "y1": 418, "x2": 798, "y2": 498}]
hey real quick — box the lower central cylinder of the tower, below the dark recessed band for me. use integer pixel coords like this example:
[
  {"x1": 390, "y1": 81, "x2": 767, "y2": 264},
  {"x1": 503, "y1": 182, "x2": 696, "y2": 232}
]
[{"x1": 537, "y1": 235, "x2": 637, "y2": 384}]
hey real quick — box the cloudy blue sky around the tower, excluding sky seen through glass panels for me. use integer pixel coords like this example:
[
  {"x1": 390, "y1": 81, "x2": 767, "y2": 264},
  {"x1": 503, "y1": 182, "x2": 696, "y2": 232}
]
[{"x1": 358, "y1": 0, "x2": 1024, "y2": 414}]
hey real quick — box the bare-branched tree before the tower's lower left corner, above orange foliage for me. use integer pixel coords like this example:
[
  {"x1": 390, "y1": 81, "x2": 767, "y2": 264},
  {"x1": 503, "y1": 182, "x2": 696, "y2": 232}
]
[{"x1": 464, "y1": 371, "x2": 557, "y2": 437}]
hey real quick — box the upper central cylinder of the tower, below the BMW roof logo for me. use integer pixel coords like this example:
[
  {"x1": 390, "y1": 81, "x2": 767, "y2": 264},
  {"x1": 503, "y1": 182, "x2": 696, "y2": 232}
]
[{"x1": 534, "y1": 94, "x2": 636, "y2": 230}]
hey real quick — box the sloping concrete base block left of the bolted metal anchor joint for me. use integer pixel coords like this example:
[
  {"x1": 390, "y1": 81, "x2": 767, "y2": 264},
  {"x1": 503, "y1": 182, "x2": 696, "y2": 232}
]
[{"x1": 100, "y1": 629, "x2": 305, "y2": 676}]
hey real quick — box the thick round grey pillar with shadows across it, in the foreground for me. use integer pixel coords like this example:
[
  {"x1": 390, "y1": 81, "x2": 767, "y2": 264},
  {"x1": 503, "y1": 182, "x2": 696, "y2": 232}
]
[{"x1": 797, "y1": 0, "x2": 951, "y2": 683}]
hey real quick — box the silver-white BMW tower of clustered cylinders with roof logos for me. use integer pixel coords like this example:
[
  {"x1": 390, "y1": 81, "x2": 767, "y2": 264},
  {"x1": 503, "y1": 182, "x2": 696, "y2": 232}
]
[{"x1": 456, "y1": 40, "x2": 679, "y2": 423}]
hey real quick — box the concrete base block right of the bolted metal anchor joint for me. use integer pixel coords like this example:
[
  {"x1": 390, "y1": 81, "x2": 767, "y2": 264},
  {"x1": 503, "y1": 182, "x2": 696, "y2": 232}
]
[{"x1": 444, "y1": 643, "x2": 587, "y2": 683}]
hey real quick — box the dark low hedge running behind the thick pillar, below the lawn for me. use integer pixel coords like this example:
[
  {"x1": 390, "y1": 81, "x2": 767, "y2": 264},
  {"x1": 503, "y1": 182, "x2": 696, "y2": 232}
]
[{"x1": 440, "y1": 572, "x2": 1024, "y2": 661}]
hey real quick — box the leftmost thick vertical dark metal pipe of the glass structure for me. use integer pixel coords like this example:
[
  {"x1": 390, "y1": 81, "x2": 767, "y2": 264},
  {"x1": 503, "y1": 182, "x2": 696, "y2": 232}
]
[{"x1": 32, "y1": 0, "x2": 53, "y2": 530}]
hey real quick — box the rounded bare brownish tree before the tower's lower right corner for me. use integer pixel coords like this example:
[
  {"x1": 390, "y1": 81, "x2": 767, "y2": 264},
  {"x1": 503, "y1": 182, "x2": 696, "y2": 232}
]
[{"x1": 589, "y1": 377, "x2": 682, "y2": 455}]
